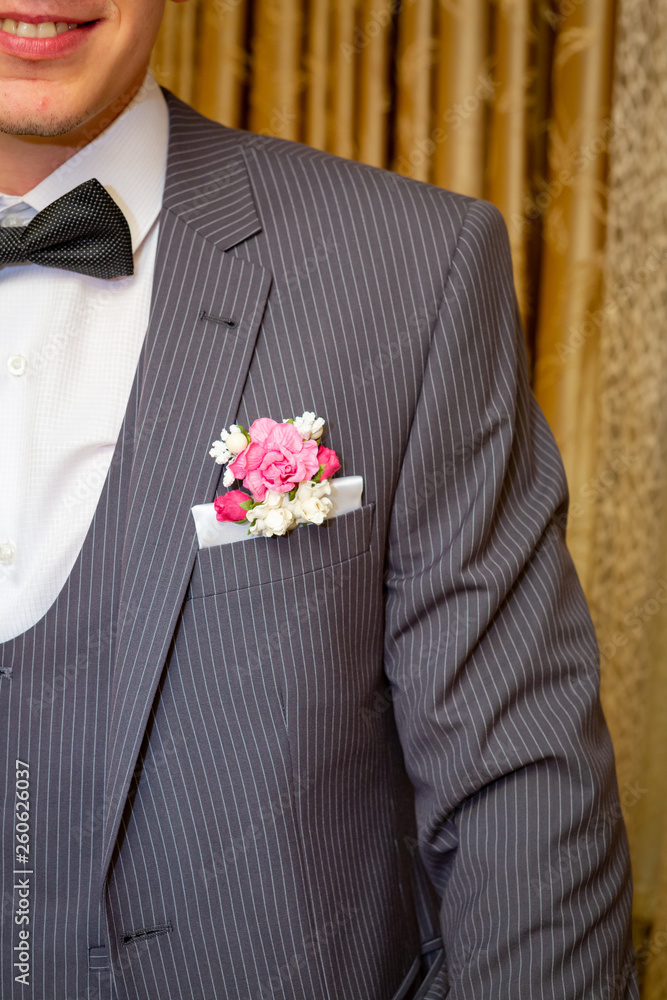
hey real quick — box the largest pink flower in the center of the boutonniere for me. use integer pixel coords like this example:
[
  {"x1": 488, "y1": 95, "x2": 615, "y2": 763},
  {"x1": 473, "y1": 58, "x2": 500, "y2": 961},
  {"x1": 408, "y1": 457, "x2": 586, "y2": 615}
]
[{"x1": 227, "y1": 417, "x2": 320, "y2": 503}]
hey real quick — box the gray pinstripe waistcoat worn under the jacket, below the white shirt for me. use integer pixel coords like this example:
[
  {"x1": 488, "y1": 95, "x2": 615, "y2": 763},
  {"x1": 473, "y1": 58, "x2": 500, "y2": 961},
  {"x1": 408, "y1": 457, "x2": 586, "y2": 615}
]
[{"x1": 0, "y1": 376, "x2": 137, "y2": 1000}]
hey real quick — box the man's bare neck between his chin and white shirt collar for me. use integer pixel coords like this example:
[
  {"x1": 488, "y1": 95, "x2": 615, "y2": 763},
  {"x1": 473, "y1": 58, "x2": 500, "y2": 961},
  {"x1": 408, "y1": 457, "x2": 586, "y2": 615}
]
[{"x1": 0, "y1": 77, "x2": 143, "y2": 195}]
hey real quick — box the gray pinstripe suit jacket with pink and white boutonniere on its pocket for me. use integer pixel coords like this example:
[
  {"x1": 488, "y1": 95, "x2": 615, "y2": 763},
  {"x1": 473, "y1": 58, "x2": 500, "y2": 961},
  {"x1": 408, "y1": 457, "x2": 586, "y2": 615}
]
[{"x1": 104, "y1": 90, "x2": 636, "y2": 1000}]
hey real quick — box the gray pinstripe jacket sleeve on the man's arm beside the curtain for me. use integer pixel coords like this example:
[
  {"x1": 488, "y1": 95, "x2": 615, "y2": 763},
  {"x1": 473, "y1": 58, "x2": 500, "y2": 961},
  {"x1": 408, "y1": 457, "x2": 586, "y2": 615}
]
[{"x1": 385, "y1": 202, "x2": 637, "y2": 1000}]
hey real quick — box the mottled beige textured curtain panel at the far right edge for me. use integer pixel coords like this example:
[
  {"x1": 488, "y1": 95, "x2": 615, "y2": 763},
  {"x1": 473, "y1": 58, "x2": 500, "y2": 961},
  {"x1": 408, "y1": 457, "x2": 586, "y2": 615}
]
[{"x1": 588, "y1": 0, "x2": 667, "y2": 1000}]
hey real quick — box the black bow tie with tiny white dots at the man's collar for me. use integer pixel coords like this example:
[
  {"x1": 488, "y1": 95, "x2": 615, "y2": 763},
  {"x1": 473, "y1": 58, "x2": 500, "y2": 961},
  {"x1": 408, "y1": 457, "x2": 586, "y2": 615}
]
[{"x1": 0, "y1": 178, "x2": 134, "y2": 278}]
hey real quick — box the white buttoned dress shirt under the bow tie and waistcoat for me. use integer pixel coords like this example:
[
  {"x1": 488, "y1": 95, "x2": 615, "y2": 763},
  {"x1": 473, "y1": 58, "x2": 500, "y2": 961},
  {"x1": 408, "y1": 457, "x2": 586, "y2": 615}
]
[{"x1": 0, "y1": 74, "x2": 169, "y2": 642}]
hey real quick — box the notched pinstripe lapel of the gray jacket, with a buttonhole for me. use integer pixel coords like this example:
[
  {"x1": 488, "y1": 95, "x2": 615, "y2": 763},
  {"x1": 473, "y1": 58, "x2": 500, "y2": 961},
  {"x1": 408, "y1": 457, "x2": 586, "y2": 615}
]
[{"x1": 102, "y1": 96, "x2": 271, "y2": 881}]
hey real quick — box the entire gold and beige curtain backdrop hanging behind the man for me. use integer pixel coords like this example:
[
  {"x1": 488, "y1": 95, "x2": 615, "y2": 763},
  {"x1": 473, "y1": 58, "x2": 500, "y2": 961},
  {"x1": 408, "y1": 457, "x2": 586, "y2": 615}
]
[{"x1": 153, "y1": 0, "x2": 667, "y2": 1000}]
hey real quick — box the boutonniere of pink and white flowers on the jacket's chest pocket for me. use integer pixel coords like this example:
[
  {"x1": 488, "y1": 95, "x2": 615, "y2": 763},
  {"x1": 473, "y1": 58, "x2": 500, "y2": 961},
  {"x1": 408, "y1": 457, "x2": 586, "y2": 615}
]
[{"x1": 209, "y1": 411, "x2": 340, "y2": 537}]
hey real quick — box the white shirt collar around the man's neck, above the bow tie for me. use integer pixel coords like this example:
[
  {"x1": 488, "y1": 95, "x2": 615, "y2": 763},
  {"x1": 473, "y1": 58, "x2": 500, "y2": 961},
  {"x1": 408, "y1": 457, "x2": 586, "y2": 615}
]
[{"x1": 5, "y1": 72, "x2": 169, "y2": 251}]
